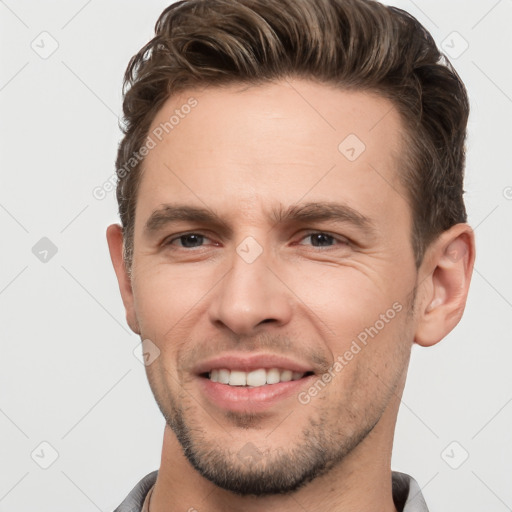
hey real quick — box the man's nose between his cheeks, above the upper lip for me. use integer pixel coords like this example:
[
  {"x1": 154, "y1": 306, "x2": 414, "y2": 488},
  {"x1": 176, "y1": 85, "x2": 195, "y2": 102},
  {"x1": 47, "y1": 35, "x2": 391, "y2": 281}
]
[{"x1": 210, "y1": 243, "x2": 292, "y2": 335}]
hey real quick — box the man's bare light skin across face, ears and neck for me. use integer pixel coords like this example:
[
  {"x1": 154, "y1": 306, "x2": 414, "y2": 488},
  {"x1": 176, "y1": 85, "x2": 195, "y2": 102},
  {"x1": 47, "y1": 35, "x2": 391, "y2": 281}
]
[{"x1": 107, "y1": 79, "x2": 474, "y2": 512}]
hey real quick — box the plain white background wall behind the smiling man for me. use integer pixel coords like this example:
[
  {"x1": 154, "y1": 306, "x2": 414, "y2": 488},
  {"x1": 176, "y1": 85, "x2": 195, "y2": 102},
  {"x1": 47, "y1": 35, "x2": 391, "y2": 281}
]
[{"x1": 0, "y1": 0, "x2": 512, "y2": 512}]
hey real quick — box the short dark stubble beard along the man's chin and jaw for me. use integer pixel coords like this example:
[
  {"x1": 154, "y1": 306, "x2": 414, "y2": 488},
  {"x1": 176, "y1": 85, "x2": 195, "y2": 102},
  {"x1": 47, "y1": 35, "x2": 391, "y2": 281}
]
[{"x1": 150, "y1": 376, "x2": 380, "y2": 497}]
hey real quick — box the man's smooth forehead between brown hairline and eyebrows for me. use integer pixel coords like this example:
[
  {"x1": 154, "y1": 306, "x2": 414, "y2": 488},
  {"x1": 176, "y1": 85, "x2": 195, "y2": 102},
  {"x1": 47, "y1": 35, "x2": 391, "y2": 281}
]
[{"x1": 137, "y1": 79, "x2": 406, "y2": 230}]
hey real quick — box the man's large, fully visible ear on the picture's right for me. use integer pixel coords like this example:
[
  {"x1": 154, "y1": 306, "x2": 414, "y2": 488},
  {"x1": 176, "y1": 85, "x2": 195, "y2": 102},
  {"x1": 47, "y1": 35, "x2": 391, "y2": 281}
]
[{"x1": 414, "y1": 224, "x2": 475, "y2": 347}]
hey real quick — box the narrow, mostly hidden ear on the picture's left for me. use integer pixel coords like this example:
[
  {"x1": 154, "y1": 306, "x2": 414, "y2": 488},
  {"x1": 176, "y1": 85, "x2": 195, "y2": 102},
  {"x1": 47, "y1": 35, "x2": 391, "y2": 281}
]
[{"x1": 107, "y1": 224, "x2": 140, "y2": 334}]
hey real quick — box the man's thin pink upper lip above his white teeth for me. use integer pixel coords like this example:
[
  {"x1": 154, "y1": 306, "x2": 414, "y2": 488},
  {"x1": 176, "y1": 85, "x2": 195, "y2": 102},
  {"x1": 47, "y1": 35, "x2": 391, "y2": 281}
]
[{"x1": 194, "y1": 352, "x2": 314, "y2": 375}]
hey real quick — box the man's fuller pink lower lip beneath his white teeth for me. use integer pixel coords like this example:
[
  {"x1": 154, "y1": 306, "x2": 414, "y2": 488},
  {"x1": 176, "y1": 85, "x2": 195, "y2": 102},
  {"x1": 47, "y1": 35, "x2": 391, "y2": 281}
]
[{"x1": 199, "y1": 375, "x2": 315, "y2": 412}]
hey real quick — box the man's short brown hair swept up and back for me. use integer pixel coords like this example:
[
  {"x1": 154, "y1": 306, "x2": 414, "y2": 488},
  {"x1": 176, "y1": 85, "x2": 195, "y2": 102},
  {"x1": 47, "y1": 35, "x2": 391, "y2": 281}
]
[{"x1": 116, "y1": 0, "x2": 469, "y2": 268}]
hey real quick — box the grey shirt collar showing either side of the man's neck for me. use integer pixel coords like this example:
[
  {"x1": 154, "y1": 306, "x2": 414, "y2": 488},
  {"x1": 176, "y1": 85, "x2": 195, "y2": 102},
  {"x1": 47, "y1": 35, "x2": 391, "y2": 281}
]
[{"x1": 114, "y1": 471, "x2": 428, "y2": 512}]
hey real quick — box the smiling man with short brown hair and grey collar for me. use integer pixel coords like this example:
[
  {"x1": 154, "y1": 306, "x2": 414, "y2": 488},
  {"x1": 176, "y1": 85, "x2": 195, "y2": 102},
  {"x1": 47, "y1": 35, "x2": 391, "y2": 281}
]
[{"x1": 107, "y1": 0, "x2": 475, "y2": 512}]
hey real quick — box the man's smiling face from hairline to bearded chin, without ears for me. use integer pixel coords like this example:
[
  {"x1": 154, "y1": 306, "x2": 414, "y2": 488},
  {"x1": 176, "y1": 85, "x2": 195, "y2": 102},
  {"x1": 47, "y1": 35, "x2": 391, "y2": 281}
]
[{"x1": 128, "y1": 80, "x2": 417, "y2": 494}]
